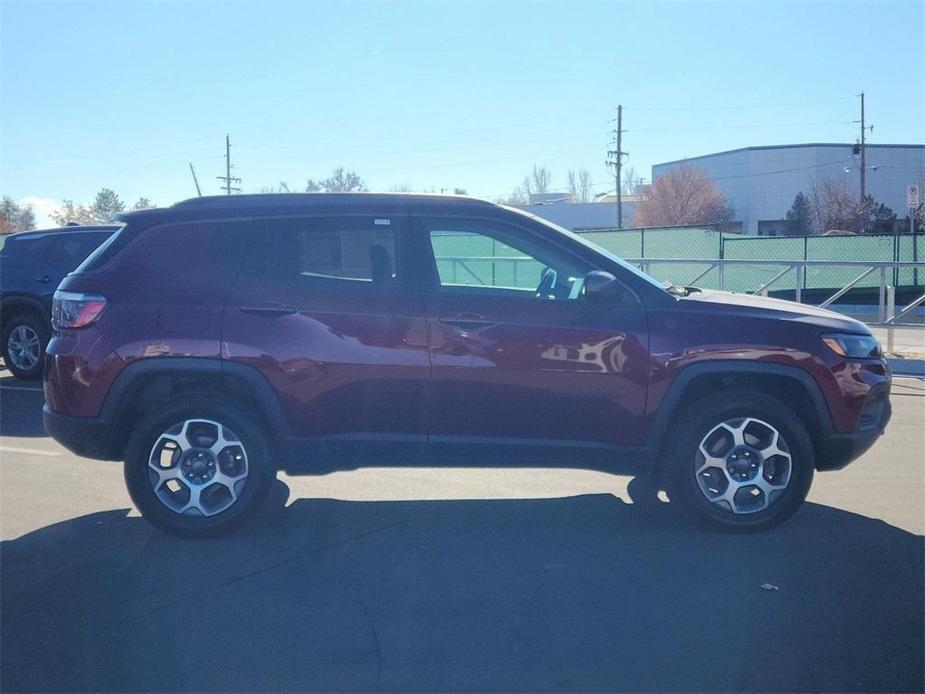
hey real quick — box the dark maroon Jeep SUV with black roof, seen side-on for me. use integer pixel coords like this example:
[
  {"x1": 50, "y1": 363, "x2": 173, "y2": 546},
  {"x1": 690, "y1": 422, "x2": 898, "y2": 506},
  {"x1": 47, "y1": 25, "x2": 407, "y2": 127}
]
[{"x1": 44, "y1": 194, "x2": 890, "y2": 536}]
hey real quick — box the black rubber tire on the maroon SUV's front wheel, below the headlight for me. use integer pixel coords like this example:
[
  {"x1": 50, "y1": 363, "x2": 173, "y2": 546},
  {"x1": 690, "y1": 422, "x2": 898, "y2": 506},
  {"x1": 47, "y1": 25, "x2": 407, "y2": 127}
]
[{"x1": 665, "y1": 391, "x2": 815, "y2": 532}]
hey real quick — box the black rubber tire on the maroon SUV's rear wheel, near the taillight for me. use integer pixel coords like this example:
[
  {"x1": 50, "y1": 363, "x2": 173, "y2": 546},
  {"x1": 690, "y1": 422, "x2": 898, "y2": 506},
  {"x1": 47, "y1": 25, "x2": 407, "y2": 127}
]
[{"x1": 124, "y1": 394, "x2": 276, "y2": 538}]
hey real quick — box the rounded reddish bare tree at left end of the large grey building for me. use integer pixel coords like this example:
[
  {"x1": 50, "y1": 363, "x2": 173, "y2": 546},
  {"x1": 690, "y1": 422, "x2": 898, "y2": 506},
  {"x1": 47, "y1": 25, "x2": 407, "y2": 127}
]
[{"x1": 633, "y1": 163, "x2": 733, "y2": 227}]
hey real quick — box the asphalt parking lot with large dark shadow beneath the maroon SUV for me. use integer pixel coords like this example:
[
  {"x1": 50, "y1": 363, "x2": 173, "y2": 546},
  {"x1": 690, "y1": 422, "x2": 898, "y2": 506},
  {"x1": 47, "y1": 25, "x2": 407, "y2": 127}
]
[{"x1": 0, "y1": 371, "x2": 925, "y2": 691}]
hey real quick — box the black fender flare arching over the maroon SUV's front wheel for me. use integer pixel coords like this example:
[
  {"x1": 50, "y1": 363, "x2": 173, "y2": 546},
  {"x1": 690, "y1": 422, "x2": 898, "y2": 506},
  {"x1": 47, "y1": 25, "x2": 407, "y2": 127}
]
[{"x1": 646, "y1": 359, "x2": 833, "y2": 454}]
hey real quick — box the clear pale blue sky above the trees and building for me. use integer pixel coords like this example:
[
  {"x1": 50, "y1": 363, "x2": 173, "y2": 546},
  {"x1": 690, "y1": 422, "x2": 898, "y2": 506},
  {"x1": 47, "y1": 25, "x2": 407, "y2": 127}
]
[{"x1": 0, "y1": 0, "x2": 925, "y2": 224}]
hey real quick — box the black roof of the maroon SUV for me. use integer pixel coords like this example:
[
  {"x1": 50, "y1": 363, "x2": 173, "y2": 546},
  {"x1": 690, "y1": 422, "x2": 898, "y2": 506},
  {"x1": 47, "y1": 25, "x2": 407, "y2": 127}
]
[{"x1": 118, "y1": 193, "x2": 506, "y2": 223}]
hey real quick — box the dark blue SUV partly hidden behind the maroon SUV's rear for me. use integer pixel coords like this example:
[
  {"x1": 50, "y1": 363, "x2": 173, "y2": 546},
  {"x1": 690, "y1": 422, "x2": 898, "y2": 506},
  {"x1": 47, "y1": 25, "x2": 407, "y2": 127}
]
[{"x1": 0, "y1": 226, "x2": 116, "y2": 380}]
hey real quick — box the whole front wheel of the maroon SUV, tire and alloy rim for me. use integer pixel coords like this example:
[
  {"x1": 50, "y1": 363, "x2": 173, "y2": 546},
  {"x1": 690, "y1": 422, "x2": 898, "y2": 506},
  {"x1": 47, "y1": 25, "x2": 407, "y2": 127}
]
[{"x1": 667, "y1": 393, "x2": 815, "y2": 531}]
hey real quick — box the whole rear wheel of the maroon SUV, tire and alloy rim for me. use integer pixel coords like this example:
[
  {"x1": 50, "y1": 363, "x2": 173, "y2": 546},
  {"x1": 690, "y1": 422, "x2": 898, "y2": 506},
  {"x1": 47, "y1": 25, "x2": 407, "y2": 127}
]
[{"x1": 125, "y1": 395, "x2": 276, "y2": 537}]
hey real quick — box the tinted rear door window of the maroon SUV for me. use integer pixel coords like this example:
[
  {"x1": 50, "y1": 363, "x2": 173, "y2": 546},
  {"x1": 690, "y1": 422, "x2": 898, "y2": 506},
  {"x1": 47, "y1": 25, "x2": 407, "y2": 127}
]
[{"x1": 266, "y1": 219, "x2": 397, "y2": 288}]
